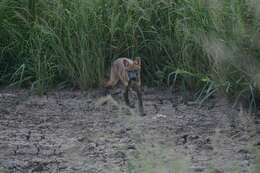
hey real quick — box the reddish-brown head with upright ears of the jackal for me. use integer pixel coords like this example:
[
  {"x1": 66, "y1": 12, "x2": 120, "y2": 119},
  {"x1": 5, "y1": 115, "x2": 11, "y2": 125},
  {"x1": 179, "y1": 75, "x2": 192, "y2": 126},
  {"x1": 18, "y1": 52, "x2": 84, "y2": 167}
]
[{"x1": 123, "y1": 57, "x2": 141, "y2": 81}]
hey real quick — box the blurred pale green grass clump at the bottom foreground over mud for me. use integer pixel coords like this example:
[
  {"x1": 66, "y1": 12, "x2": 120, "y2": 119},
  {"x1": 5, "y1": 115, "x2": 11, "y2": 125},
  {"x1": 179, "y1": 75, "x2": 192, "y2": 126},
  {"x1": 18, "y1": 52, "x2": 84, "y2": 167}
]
[{"x1": 128, "y1": 144, "x2": 191, "y2": 173}]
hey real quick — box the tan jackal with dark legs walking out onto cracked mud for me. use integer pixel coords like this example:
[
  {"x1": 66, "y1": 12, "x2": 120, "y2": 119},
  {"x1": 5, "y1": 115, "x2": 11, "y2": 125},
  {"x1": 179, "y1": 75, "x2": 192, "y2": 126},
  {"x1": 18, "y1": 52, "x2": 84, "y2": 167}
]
[{"x1": 105, "y1": 57, "x2": 145, "y2": 116}]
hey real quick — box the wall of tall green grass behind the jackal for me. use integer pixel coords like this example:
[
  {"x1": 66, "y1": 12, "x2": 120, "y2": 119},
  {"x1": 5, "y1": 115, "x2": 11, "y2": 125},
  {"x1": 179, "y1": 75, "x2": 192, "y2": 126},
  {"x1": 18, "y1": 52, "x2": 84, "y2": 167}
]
[{"x1": 0, "y1": 0, "x2": 260, "y2": 108}]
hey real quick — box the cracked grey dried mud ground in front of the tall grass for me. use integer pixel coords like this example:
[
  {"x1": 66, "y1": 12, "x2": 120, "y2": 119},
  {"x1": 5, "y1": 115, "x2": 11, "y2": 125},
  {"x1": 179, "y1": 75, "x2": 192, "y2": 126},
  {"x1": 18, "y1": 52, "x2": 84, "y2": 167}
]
[{"x1": 0, "y1": 89, "x2": 260, "y2": 173}]
